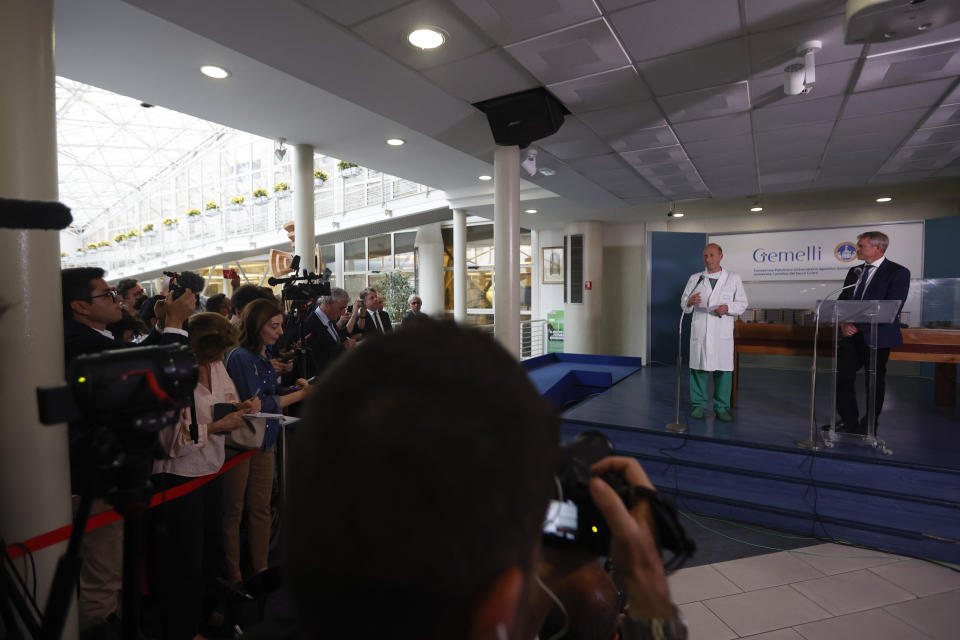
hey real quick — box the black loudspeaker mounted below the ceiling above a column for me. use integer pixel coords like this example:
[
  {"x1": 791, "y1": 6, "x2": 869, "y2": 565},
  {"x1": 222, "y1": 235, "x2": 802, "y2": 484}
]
[{"x1": 473, "y1": 87, "x2": 570, "y2": 149}]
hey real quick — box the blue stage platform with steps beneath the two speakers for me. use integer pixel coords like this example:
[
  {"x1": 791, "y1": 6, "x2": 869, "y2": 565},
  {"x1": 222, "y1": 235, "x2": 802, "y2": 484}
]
[{"x1": 548, "y1": 355, "x2": 960, "y2": 562}]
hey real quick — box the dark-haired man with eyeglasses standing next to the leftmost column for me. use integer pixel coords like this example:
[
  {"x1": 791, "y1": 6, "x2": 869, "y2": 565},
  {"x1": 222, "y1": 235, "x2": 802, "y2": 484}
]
[{"x1": 60, "y1": 267, "x2": 196, "y2": 634}]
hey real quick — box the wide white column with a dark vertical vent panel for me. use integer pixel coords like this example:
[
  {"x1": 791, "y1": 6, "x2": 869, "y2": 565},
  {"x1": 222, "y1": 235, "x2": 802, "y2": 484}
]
[{"x1": 563, "y1": 222, "x2": 603, "y2": 354}]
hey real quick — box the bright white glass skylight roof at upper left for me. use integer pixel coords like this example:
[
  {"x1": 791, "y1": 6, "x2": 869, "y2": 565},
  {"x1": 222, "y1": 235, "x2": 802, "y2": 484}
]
[{"x1": 56, "y1": 77, "x2": 233, "y2": 228}]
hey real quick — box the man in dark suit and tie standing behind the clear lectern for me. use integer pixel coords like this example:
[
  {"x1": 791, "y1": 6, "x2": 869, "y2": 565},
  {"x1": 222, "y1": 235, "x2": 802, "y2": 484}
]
[{"x1": 837, "y1": 231, "x2": 910, "y2": 435}]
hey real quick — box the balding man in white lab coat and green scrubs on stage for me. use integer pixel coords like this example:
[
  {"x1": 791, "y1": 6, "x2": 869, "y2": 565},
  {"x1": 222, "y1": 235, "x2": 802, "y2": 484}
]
[{"x1": 680, "y1": 243, "x2": 747, "y2": 422}]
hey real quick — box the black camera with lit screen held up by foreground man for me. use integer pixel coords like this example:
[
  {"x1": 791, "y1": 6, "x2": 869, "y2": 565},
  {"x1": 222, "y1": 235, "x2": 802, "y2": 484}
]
[{"x1": 543, "y1": 431, "x2": 697, "y2": 571}]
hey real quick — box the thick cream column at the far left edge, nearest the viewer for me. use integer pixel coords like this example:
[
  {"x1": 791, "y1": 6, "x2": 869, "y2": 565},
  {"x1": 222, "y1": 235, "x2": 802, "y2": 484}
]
[{"x1": 0, "y1": 0, "x2": 77, "y2": 638}]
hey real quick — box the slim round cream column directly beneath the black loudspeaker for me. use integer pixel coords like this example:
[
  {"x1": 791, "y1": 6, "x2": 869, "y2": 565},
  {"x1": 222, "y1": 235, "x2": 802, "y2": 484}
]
[{"x1": 493, "y1": 146, "x2": 520, "y2": 358}]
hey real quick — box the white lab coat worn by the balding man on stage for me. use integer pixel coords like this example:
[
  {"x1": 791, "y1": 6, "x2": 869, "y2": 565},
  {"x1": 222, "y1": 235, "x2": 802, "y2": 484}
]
[{"x1": 680, "y1": 267, "x2": 747, "y2": 371}]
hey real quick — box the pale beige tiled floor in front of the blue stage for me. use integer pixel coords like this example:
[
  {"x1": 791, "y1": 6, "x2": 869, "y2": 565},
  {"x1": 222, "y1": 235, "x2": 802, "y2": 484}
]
[{"x1": 670, "y1": 544, "x2": 960, "y2": 640}]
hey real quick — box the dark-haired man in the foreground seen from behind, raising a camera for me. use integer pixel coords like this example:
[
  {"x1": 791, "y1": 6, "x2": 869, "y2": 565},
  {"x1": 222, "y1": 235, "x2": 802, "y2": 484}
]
[{"x1": 284, "y1": 320, "x2": 675, "y2": 640}]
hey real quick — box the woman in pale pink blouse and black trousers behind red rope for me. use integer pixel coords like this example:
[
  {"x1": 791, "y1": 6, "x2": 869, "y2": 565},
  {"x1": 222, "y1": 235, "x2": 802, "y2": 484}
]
[{"x1": 150, "y1": 313, "x2": 260, "y2": 640}]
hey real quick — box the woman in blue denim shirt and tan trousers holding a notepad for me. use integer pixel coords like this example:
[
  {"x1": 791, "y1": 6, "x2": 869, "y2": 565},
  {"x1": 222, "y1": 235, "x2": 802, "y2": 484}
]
[{"x1": 223, "y1": 299, "x2": 307, "y2": 582}]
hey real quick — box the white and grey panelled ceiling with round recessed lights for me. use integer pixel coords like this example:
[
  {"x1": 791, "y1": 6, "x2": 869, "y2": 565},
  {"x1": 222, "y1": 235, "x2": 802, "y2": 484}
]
[{"x1": 55, "y1": 0, "x2": 960, "y2": 227}]
